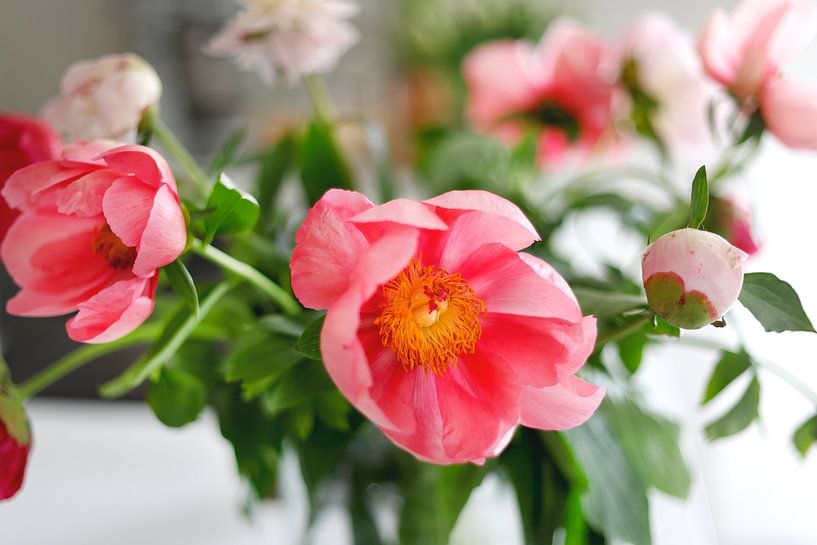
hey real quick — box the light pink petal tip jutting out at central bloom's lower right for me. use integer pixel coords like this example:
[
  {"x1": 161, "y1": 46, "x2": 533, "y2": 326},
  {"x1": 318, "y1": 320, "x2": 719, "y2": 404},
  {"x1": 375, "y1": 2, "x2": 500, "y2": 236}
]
[{"x1": 520, "y1": 375, "x2": 604, "y2": 430}]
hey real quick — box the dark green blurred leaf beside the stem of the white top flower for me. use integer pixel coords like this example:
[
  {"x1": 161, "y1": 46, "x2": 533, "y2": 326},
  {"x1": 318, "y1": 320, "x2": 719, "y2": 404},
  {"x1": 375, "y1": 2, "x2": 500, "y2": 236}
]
[{"x1": 299, "y1": 120, "x2": 353, "y2": 203}]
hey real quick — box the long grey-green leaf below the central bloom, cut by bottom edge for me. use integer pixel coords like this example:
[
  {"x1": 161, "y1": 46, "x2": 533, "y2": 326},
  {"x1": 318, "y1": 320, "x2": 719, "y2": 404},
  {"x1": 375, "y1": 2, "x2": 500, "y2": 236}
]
[{"x1": 565, "y1": 413, "x2": 651, "y2": 545}]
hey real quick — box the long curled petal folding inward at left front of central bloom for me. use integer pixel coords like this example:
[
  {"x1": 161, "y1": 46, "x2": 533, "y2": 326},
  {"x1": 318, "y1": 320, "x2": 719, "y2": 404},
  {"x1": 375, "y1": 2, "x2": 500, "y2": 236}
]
[{"x1": 321, "y1": 227, "x2": 417, "y2": 428}]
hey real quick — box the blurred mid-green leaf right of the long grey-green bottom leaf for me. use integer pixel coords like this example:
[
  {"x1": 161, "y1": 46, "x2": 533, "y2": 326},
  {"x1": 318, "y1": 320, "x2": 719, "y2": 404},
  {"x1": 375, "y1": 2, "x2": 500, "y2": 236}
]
[{"x1": 602, "y1": 396, "x2": 692, "y2": 498}]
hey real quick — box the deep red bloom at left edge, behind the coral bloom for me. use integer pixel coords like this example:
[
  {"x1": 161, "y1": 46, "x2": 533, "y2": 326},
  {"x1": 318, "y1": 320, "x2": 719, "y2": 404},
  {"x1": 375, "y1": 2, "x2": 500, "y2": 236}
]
[{"x1": 0, "y1": 113, "x2": 62, "y2": 241}]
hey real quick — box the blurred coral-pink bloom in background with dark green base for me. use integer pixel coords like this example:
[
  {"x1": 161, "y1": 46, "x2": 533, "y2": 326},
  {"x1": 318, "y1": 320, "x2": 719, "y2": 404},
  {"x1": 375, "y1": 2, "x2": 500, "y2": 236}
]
[{"x1": 463, "y1": 19, "x2": 615, "y2": 163}]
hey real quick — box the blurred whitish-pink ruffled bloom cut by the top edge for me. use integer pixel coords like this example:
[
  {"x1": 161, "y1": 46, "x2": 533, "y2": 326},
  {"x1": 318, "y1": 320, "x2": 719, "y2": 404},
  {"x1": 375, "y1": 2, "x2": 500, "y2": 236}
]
[{"x1": 207, "y1": 0, "x2": 358, "y2": 85}]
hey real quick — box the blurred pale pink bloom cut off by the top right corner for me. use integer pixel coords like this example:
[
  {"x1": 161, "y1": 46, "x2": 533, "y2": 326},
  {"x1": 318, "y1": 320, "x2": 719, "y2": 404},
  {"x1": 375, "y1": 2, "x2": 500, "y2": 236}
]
[{"x1": 698, "y1": 0, "x2": 817, "y2": 149}]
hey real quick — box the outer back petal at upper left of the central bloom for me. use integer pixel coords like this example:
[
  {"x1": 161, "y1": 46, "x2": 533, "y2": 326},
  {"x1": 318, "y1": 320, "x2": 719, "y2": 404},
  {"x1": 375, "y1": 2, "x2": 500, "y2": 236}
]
[{"x1": 290, "y1": 189, "x2": 372, "y2": 309}]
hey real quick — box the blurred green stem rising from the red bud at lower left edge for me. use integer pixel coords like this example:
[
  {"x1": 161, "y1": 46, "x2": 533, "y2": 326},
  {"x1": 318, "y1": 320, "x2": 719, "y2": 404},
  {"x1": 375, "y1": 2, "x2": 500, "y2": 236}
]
[{"x1": 17, "y1": 324, "x2": 162, "y2": 399}]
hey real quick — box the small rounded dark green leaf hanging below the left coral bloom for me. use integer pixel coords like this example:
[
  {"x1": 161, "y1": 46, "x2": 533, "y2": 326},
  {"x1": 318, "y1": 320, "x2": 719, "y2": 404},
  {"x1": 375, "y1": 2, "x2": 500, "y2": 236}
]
[{"x1": 147, "y1": 367, "x2": 207, "y2": 428}]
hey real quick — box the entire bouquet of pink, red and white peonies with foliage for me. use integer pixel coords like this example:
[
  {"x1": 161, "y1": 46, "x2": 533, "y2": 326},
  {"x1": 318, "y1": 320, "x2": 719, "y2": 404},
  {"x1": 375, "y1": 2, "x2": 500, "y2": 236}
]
[{"x1": 0, "y1": 0, "x2": 817, "y2": 545}]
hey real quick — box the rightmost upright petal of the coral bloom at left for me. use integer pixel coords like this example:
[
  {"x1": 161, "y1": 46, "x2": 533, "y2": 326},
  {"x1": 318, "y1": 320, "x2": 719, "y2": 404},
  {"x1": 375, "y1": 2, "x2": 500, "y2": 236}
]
[{"x1": 133, "y1": 185, "x2": 187, "y2": 277}]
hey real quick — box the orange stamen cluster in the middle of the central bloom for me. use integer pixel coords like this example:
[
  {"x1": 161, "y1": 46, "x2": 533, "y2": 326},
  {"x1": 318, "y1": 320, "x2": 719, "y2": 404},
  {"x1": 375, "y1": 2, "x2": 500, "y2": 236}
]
[{"x1": 374, "y1": 259, "x2": 485, "y2": 374}]
